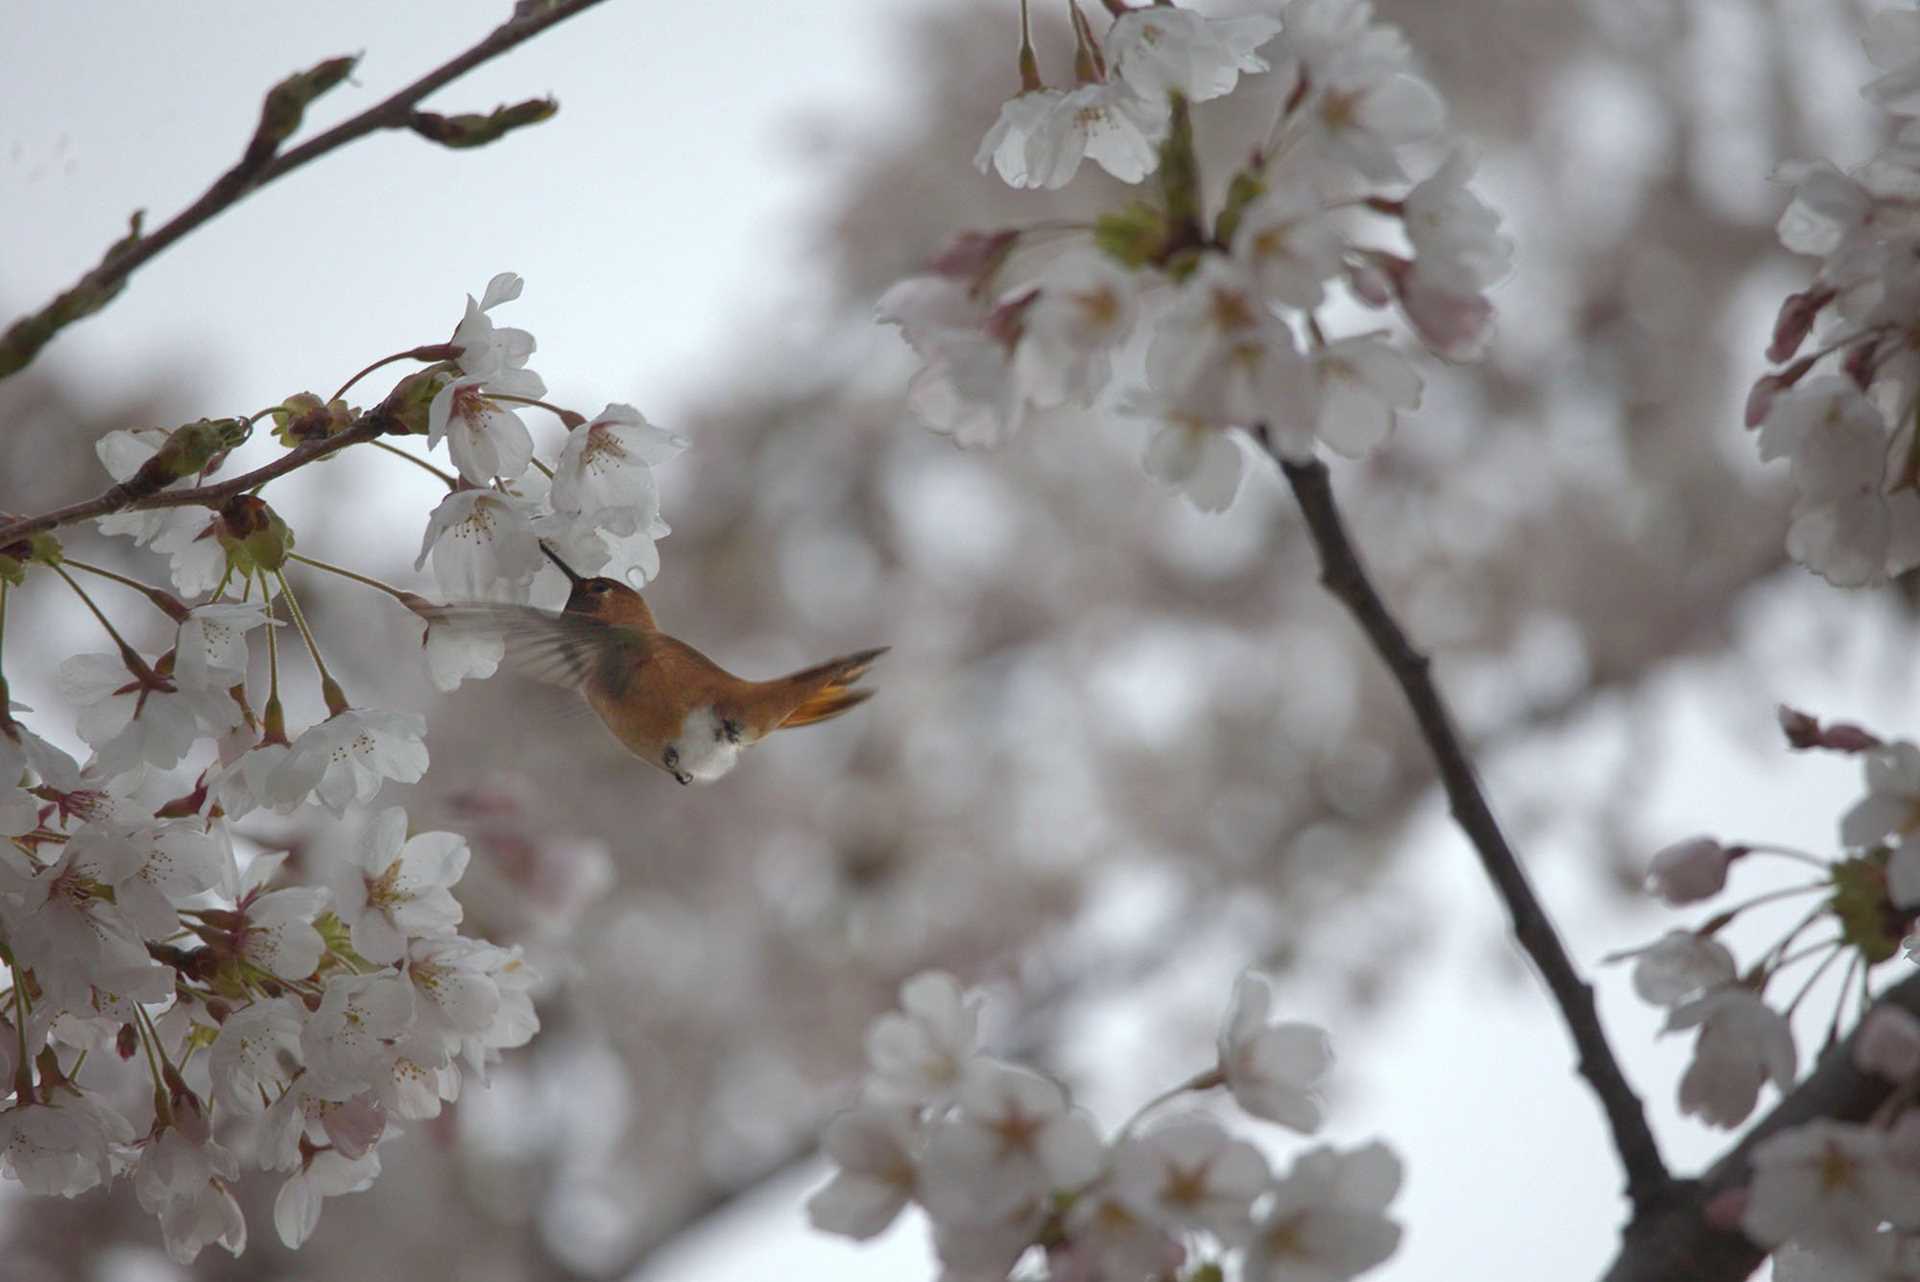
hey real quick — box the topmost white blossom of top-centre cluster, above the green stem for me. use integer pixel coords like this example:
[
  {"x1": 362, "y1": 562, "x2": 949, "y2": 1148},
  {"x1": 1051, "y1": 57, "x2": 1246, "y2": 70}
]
[{"x1": 1104, "y1": 6, "x2": 1281, "y2": 102}]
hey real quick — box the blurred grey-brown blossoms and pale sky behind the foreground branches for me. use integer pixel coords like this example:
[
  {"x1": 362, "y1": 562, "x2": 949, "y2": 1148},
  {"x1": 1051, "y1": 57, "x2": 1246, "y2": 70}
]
[{"x1": 0, "y1": 0, "x2": 1920, "y2": 1282}]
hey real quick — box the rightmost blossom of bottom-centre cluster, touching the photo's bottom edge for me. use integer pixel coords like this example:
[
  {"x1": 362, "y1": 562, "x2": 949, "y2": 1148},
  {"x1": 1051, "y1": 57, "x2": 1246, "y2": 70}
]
[{"x1": 1242, "y1": 1142, "x2": 1402, "y2": 1282}]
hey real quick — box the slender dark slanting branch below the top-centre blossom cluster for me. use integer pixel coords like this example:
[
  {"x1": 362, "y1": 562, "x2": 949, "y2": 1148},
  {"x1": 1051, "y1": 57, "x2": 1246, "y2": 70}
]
[{"x1": 1254, "y1": 449, "x2": 1672, "y2": 1219}]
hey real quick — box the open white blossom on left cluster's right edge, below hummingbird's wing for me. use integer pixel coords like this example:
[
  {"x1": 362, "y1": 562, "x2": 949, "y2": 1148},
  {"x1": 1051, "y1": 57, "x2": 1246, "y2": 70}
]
[{"x1": 330, "y1": 806, "x2": 468, "y2": 965}]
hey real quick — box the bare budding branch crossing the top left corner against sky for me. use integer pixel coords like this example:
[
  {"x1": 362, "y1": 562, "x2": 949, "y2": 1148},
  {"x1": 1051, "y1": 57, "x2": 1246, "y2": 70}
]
[{"x1": 0, "y1": 0, "x2": 601, "y2": 378}]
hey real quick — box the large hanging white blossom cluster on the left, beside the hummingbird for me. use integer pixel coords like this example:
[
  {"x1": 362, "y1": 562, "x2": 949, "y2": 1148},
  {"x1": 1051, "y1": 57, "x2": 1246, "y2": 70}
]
[{"x1": 0, "y1": 274, "x2": 684, "y2": 1263}]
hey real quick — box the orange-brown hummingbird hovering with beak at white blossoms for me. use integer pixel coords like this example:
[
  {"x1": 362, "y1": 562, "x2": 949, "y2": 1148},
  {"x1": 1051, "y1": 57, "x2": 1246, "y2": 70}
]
[{"x1": 430, "y1": 541, "x2": 887, "y2": 785}]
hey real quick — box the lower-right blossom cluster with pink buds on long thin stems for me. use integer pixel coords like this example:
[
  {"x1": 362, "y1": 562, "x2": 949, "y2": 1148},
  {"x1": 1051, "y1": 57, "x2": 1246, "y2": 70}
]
[{"x1": 1619, "y1": 708, "x2": 1920, "y2": 1278}]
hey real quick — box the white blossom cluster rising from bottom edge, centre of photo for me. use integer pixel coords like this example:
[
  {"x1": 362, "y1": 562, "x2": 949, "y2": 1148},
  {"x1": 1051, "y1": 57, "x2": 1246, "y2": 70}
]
[{"x1": 808, "y1": 971, "x2": 1400, "y2": 1282}]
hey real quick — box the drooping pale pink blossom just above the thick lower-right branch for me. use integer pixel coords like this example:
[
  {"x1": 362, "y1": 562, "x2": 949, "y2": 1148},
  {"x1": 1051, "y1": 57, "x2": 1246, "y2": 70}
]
[{"x1": 1665, "y1": 986, "x2": 1799, "y2": 1127}]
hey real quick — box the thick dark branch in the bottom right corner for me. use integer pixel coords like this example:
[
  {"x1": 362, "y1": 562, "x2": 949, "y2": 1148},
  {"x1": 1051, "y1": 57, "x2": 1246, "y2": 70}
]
[{"x1": 1605, "y1": 975, "x2": 1920, "y2": 1282}]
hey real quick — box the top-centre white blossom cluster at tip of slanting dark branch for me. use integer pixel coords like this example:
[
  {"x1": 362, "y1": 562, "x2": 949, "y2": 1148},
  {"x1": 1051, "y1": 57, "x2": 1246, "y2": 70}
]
[{"x1": 879, "y1": 0, "x2": 1511, "y2": 510}]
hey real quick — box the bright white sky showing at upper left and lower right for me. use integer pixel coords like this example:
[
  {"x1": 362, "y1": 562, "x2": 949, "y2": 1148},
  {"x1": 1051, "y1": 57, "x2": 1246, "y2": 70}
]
[{"x1": 0, "y1": 0, "x2": 1916, "y2": 1282}]
